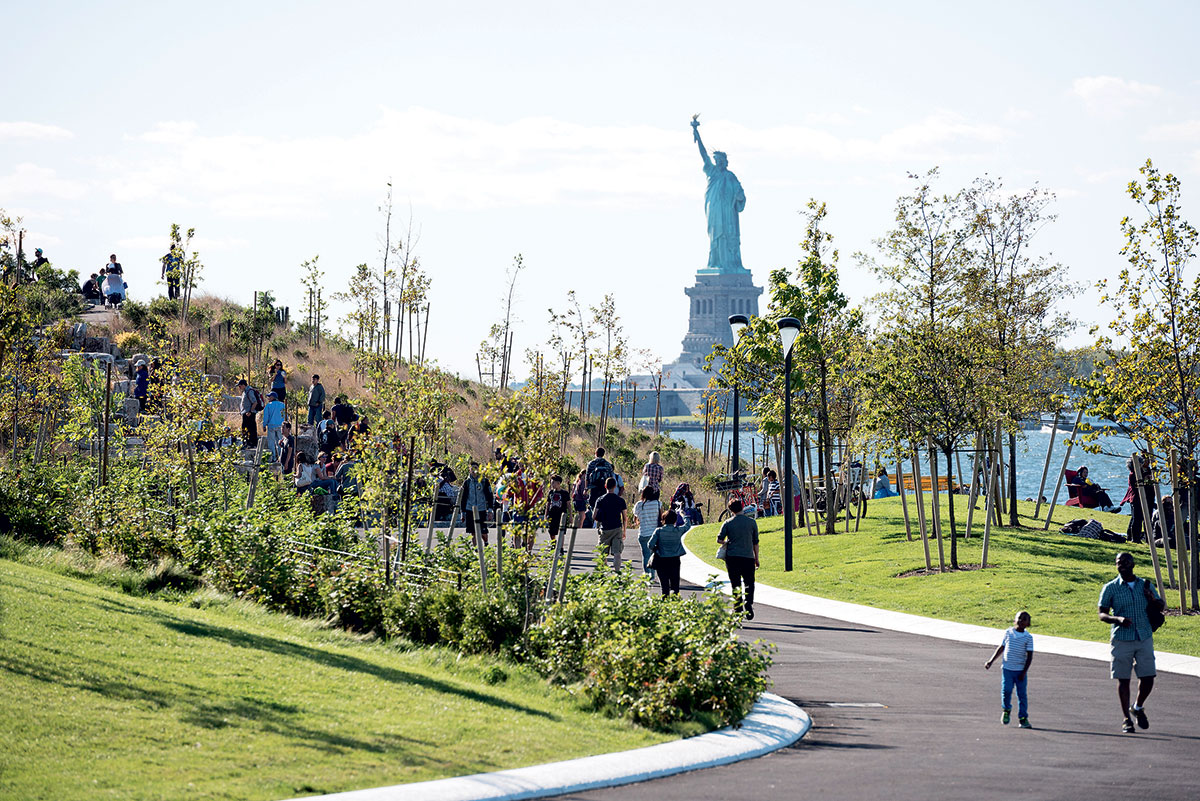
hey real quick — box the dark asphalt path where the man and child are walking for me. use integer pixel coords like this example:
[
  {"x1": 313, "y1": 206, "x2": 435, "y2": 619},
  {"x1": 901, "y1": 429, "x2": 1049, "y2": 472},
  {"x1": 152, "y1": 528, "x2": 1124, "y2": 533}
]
[{"x1": 544, "y1": 530, "x2": 1200, "y2": 801}]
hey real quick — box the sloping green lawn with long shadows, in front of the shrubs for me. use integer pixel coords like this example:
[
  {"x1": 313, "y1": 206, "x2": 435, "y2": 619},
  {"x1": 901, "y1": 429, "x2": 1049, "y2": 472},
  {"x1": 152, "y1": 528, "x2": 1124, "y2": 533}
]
[{"x1": 0, "y1": 560, "x2": 668, "y2": 801}]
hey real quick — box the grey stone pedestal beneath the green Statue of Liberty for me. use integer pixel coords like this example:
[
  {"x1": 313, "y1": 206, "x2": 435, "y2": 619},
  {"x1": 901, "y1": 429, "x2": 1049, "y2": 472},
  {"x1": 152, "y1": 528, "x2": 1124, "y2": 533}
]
[{"x1": 667, "y1": 270, "x2": 762, "y2": 387}]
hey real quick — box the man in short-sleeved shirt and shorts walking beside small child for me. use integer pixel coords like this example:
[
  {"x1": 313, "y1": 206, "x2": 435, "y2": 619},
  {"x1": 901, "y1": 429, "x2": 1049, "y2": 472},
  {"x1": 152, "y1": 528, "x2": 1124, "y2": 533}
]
[{"x1": 1100, "y1": 553, "x2": 1162, "y2": 734}]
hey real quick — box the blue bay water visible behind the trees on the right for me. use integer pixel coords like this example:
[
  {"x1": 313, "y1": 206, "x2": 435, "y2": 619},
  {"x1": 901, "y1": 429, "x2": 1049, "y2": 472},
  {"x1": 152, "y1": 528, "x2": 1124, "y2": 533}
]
[{"x1": 671, "y1": 428, "x2": 1142, "y2": 513}]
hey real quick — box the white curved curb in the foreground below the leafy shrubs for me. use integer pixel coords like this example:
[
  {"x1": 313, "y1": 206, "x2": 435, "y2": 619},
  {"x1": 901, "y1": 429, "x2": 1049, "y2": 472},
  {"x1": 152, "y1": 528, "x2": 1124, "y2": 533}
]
[{"x1": 279, "y1": 693, "x2": 812, "y2": 801}]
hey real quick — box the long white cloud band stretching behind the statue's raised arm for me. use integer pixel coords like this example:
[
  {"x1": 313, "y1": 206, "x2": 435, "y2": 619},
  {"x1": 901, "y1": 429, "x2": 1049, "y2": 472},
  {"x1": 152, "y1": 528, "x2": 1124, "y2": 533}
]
[{"x1": 98, "y1": 108, "x2": 1009, "y2": 219}]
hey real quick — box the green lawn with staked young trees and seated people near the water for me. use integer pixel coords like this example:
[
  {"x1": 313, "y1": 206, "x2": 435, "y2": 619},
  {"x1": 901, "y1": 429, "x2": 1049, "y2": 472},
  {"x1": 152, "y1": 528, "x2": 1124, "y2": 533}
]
[{"x1": 688, "y1": 494, "x2": 1200, "y2": 656}]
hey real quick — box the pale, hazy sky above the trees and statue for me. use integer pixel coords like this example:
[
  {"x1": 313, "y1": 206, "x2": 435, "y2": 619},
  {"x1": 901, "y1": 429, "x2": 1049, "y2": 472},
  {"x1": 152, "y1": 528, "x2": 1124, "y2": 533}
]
[{"x1": 7, "y1": 2, "x2": 1200, "y2": 374}]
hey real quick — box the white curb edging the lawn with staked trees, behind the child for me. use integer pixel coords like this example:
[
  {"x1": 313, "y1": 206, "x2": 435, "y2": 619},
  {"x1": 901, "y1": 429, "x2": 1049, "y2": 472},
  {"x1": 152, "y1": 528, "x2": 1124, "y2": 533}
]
[{"x1": 680, "y1": 553, "x2": 1200, "y2": 676}]
